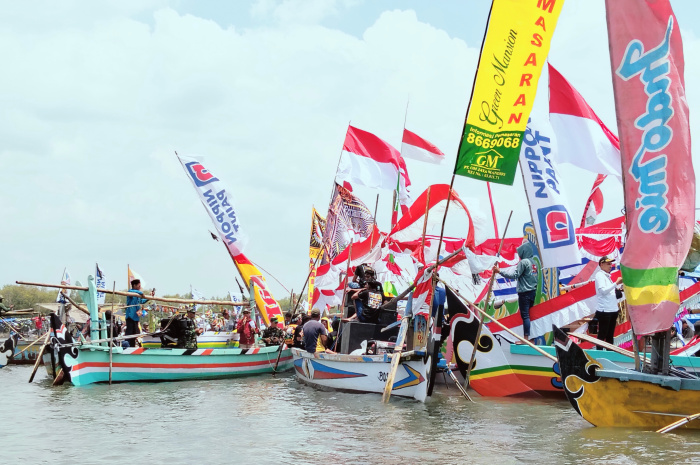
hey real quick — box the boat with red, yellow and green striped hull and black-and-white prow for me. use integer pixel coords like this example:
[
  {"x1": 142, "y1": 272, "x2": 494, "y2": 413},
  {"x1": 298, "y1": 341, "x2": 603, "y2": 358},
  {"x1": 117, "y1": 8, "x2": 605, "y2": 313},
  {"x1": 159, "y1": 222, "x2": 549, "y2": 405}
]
[{"x1": 451, "y1": 314, "x2": 700, "y2": 397}]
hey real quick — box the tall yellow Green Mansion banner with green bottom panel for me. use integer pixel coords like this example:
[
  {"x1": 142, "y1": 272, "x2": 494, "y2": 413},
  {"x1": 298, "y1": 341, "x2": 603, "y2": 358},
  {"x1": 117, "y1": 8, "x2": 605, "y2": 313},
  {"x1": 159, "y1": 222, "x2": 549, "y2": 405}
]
[{"x1": 455, "y1": 0, "x2": 564, "y2": 185}]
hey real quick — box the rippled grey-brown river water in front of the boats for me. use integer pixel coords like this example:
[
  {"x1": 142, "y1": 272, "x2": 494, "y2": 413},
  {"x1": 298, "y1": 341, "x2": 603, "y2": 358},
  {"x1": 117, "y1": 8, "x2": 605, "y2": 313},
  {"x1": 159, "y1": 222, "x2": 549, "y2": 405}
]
[{"x1": 0, "y1": 366, "x2": 700, "y2": 465}]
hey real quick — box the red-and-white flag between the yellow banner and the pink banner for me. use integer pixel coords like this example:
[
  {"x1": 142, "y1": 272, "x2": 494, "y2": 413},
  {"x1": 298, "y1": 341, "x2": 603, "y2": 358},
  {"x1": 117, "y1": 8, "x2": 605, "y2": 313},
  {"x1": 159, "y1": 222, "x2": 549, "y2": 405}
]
[{"x1": 549, "y1": 65, "x2": 622, "y2": 178}]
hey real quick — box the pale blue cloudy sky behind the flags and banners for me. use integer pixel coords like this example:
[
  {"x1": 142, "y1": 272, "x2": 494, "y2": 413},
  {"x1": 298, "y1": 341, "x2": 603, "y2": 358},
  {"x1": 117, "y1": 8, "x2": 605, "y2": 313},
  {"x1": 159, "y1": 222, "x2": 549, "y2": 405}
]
[{"x1": 0, "y1": 0, "x2": 700, "y2": 298}]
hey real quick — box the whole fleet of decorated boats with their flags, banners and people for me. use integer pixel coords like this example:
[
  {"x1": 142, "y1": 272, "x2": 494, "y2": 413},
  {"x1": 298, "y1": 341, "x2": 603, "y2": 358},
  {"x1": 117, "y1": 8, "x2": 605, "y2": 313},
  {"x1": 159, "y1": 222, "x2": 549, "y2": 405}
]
[{"x1": 0, "y1": 0, "x2": 700, "y2": 432}]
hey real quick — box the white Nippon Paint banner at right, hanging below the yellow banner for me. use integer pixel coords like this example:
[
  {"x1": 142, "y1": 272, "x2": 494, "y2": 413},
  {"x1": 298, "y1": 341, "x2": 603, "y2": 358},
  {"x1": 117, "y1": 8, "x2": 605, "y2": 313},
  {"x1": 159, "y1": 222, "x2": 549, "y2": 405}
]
[{"x1": 520, "y1": 119, "x2": 581, "y2": 268}]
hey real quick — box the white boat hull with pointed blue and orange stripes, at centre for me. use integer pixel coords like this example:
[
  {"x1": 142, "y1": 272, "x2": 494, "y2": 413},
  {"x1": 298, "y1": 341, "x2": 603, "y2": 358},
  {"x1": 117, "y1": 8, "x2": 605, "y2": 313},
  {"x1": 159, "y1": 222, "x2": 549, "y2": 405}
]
[{"x1": 292, "y1": 348, "x2": 430, "y2": 402}]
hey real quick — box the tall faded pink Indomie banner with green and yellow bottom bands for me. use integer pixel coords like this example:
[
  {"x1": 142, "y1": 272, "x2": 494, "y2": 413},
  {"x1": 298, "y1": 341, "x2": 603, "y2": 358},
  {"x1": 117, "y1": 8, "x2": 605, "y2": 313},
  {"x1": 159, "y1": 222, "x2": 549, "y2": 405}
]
[{"x1": 606, "y1": 0, "x2": 695, "y2": 335}]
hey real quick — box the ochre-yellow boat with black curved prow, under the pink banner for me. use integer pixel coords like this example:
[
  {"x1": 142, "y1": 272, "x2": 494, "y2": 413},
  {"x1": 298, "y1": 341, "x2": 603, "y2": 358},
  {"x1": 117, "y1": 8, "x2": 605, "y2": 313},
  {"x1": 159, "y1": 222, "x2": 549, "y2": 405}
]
[{"x1": 553, "y1": 327, "x2": 700, "y2": 429}]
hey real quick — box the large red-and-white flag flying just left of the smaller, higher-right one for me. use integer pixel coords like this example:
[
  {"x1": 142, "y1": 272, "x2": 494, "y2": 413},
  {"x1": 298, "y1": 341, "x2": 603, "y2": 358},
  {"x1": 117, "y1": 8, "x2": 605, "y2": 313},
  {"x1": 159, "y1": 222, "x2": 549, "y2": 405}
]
[{"x1": 335, "y1": 126, "x2": 411, "y2": 205}]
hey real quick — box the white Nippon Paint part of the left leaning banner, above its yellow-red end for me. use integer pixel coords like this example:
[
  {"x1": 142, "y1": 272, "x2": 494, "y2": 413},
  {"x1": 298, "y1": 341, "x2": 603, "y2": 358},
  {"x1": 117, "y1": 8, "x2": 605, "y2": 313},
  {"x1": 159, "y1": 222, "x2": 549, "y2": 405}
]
[{"x1": 178, "y1": 155, "x2": 248, "y2": 255}]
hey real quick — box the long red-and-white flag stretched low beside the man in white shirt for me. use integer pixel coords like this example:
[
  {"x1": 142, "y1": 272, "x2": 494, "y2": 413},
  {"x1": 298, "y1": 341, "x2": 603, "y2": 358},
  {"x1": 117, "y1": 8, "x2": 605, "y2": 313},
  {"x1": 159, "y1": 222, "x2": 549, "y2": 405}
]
[{"x1": 487, "y1": 282, "x2": 596, "y2": 340}]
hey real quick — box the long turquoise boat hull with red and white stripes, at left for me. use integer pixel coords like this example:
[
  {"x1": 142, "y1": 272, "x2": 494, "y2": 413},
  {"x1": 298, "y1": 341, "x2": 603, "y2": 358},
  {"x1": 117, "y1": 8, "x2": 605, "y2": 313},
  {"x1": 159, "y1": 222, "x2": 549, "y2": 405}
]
[{"x1": 44, "y1": 346, "x2": 292, "y2": 386}]
